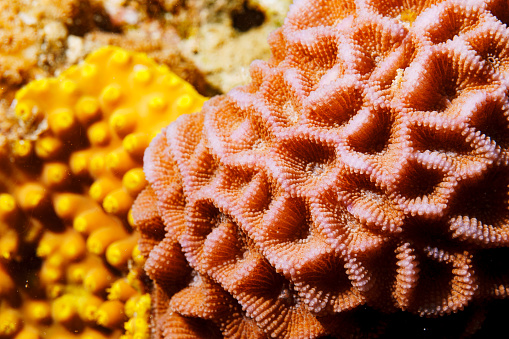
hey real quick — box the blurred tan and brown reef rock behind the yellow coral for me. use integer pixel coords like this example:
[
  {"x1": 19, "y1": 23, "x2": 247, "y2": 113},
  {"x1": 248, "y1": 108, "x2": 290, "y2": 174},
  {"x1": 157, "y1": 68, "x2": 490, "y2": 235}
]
[{"x1": 0, "y1": 0, "x2": 289, "y2": 122}]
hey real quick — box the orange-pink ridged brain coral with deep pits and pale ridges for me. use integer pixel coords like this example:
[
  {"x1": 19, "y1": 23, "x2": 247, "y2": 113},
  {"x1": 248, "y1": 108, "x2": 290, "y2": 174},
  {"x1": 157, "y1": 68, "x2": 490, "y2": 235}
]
[{"x1": 133, "y1": 0, "x2": 509, "y2": 338}]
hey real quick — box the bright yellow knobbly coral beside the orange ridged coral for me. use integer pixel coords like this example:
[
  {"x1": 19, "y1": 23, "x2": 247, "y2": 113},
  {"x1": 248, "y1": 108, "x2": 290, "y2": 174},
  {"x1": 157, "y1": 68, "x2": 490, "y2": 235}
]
[{"x1": 0, "y1": 47, "x2": 204, "y2": 339}]
